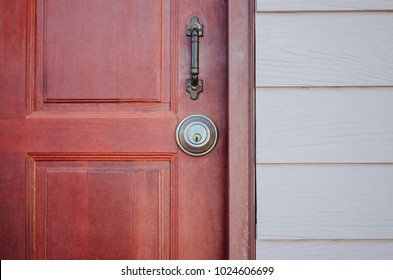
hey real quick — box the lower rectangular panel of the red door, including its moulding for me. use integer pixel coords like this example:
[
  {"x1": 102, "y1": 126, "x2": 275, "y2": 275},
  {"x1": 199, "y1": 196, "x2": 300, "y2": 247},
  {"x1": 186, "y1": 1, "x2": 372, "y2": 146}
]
[{"x1": 28, "y1": 159, "x2": 170, "y2": 259}]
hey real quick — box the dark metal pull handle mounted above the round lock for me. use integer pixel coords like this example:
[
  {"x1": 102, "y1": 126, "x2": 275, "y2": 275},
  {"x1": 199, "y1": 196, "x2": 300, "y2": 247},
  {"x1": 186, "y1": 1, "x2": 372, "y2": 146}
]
[{"x1": 186, "y1": 16, "x2": 203, "y2": 100}]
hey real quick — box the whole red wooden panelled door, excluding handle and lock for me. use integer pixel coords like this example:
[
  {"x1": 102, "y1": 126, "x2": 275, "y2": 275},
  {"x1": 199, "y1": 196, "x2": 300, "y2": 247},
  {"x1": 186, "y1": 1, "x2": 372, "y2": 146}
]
[{"x1": 0, "y1": 0, "x2": 228, "y2": 259}]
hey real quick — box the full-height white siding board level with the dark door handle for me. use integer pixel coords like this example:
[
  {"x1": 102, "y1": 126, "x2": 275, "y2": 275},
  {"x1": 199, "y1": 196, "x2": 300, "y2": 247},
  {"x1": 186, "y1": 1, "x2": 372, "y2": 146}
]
[{"x1": 256, "y1": 13, "x2": 393, "y2": 87}]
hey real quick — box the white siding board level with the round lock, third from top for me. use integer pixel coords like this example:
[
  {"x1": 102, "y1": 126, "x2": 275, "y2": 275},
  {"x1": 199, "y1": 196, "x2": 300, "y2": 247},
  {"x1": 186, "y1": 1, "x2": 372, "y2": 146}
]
[{"x1": 256, "y1": 88, "x2": 393, "y2": 163}]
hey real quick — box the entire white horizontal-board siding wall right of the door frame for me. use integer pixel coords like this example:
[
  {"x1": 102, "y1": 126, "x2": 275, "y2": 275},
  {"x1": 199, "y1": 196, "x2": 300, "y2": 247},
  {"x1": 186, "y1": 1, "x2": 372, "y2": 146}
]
[{"x1": 255, "y1": 0, "x2": 393, "y2": 259}]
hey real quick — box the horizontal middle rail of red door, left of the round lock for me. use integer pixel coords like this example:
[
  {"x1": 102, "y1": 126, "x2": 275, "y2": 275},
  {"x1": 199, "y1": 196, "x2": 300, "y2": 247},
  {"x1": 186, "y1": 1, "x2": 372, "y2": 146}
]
[{"x1": 0, "y1": 116, "x2": 177, "y2": 155}]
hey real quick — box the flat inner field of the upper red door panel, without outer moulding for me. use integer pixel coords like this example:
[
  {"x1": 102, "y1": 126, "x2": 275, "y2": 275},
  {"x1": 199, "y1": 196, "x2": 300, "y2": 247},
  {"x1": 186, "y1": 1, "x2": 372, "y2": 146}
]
[{"x1": 43, "y1": 0, "x2": 162, "y2": 102}]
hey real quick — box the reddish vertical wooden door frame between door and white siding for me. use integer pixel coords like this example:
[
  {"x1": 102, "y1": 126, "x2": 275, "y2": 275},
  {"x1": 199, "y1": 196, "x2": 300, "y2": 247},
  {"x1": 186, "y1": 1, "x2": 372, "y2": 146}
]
[{"x1": 228, "y1": 0, "x2": 255, "y2": 259}]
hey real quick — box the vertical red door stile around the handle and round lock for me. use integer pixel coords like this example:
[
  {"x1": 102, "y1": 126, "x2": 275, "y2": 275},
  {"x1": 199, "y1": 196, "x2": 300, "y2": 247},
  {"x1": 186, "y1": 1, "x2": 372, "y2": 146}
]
[{"x1": 175, "y1": 0, "x2": 228, "y2": 259}]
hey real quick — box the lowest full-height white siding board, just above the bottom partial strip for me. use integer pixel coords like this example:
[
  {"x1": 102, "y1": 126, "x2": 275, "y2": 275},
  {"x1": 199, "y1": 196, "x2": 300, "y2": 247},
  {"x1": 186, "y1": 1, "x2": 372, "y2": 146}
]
[{"x1": 257, "y1": 164, "x2": 393, "y2": 240}]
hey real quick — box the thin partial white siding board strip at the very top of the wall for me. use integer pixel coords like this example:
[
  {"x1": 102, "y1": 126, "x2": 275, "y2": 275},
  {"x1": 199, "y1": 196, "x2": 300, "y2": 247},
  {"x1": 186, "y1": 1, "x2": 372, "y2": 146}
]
[{"x1": 257, "y1": 0, "x2": 393, "y2": 12}]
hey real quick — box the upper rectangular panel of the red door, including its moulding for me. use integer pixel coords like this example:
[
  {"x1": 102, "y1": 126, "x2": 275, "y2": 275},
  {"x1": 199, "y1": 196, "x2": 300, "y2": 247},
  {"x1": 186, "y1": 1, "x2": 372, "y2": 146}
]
[{"x1": 27, "y1": 0, "x2": 171, "y2": 113}]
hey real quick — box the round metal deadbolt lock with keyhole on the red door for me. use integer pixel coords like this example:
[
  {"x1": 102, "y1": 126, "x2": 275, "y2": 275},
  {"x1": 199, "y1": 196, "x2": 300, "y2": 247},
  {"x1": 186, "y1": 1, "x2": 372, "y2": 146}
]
[{"x1": 176, "y1": 115, "x2": 218, "y2": 157}]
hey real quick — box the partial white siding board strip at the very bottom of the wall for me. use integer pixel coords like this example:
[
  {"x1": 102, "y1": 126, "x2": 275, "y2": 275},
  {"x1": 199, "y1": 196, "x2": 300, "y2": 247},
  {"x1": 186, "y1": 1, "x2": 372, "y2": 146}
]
[{"x1": 256, "y1": 240, "x2": 393, "y2": 260}]
